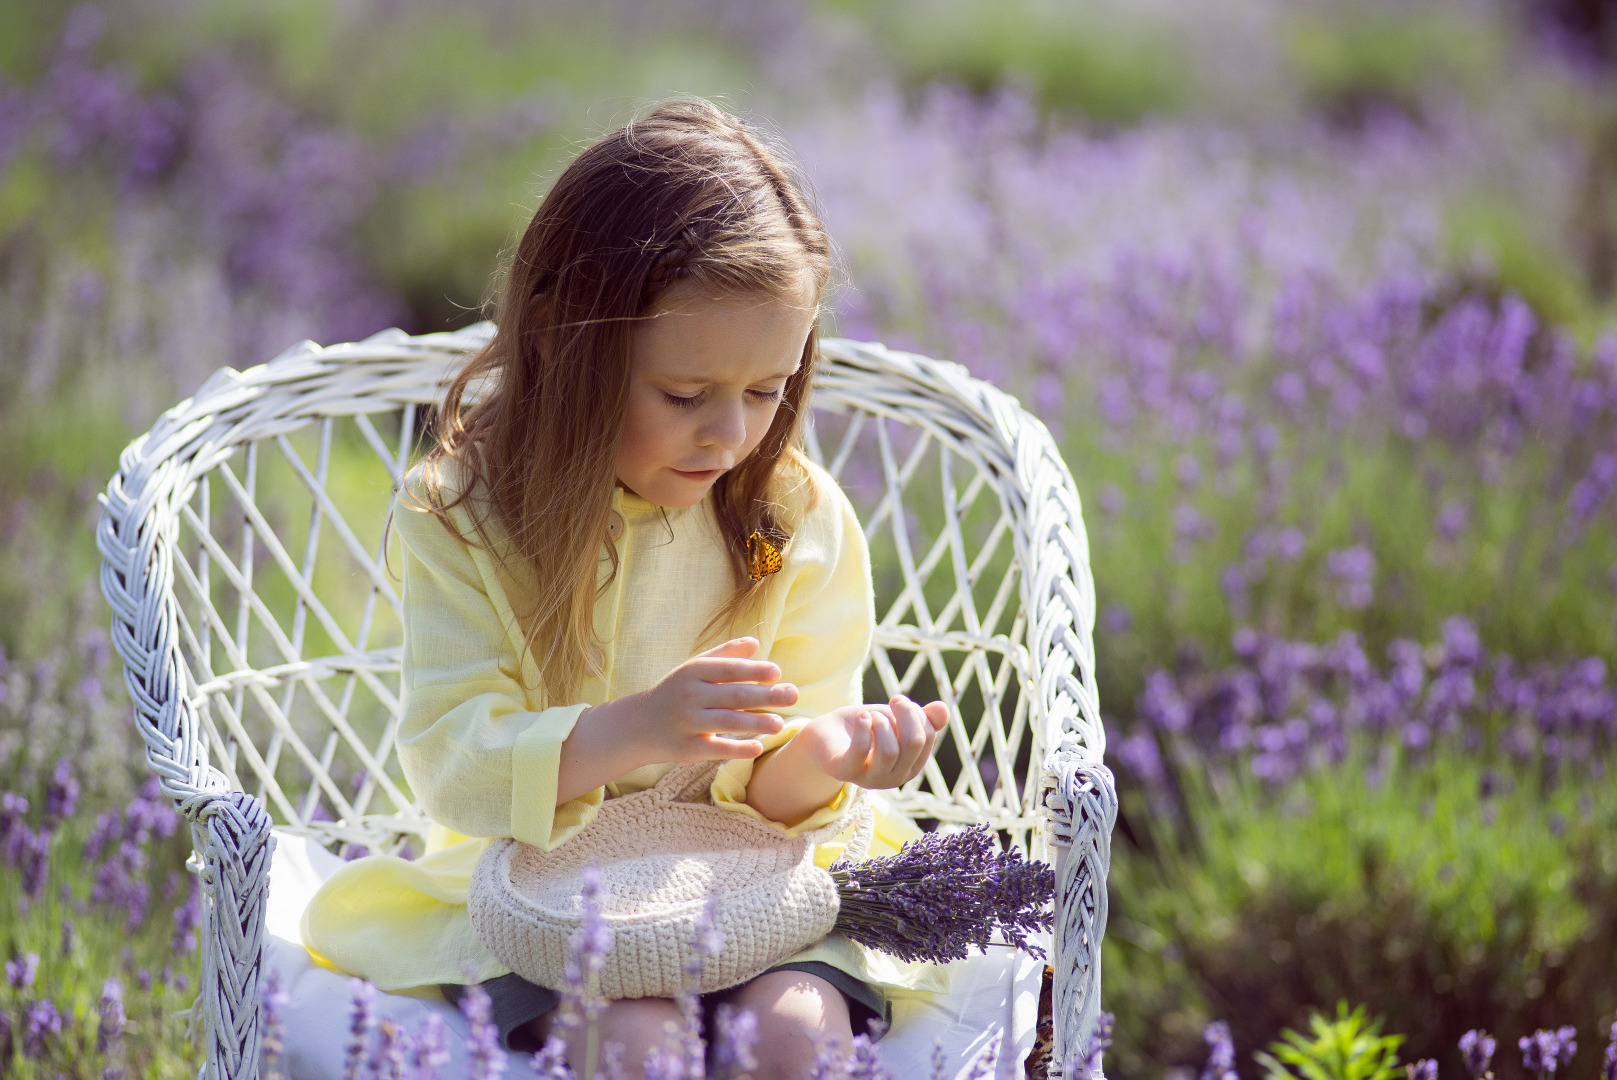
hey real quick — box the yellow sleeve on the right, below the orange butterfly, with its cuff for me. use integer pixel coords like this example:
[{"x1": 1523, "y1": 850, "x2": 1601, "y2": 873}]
[{"x1": 711, "y1": 470, "x2": 876, "y2": 834}]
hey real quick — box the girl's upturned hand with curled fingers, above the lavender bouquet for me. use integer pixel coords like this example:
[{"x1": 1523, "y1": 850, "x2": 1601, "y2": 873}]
[{"x1": 792, "y1": 694, "x2": 949, "y2": 787}]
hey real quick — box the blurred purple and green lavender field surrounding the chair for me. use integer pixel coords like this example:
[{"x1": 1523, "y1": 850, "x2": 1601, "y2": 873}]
[{"x1": 0, "y1": 0, "x2": 1617, "y2": 1080}]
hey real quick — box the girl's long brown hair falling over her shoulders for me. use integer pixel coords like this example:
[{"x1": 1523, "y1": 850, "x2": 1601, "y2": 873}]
[{"x1": 425, "y1": 100, "x2": 831, "y2": 700}]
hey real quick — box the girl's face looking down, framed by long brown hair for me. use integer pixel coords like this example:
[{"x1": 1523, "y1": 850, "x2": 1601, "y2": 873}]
[{"x1": 618, "y1": 284, "x2": 817, "y2": 508}]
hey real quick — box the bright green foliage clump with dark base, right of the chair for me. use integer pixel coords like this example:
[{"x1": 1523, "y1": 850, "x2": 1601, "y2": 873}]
[{"x1": 1104, "y1": 742, "x2": 1617, "y2": 1075}]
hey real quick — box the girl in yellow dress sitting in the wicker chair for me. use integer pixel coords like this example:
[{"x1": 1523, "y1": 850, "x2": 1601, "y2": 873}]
[{"x1": 304, "y1": 100, "x2": 946, "y2": 1077}]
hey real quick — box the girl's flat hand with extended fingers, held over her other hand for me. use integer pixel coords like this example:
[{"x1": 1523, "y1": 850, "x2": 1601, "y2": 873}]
[{"x1": 632, "y1": 637, "x2": 797, "y2": 761}]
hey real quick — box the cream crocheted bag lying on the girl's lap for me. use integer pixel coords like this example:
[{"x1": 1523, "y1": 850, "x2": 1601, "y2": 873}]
[{"x1": 467, "y1": 761, "x2": 873, "y2": 1001}]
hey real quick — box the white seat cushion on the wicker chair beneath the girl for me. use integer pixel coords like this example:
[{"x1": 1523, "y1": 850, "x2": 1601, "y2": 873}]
[{"x1": 264, "y1": 831, "x2": 1045, "y2": 1080}]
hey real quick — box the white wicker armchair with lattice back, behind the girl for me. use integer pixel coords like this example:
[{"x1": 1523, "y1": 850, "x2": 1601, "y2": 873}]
[{"x1": 97, "y1": 323, "x2": 1116, "y2": 1080}]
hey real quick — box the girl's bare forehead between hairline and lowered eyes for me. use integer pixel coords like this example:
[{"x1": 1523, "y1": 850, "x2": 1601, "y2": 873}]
[{"x1": 631, "y1": 293, "x2": 818, "y2": 382}]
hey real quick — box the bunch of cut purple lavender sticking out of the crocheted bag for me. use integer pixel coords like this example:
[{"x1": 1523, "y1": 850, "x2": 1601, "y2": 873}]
[{"x1": 831, "y1": 825, "x2": 1056, "y2": 964}]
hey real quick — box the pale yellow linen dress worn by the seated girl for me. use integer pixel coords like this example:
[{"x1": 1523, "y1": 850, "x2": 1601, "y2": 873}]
[{"x1": 302, "y1": 452, "x2": 948, "y2": 996}]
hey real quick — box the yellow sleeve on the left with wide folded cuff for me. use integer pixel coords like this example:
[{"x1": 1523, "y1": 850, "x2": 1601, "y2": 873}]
[{"x1": 393, "y1": 474, "x2": 602, "y2": 849}]
